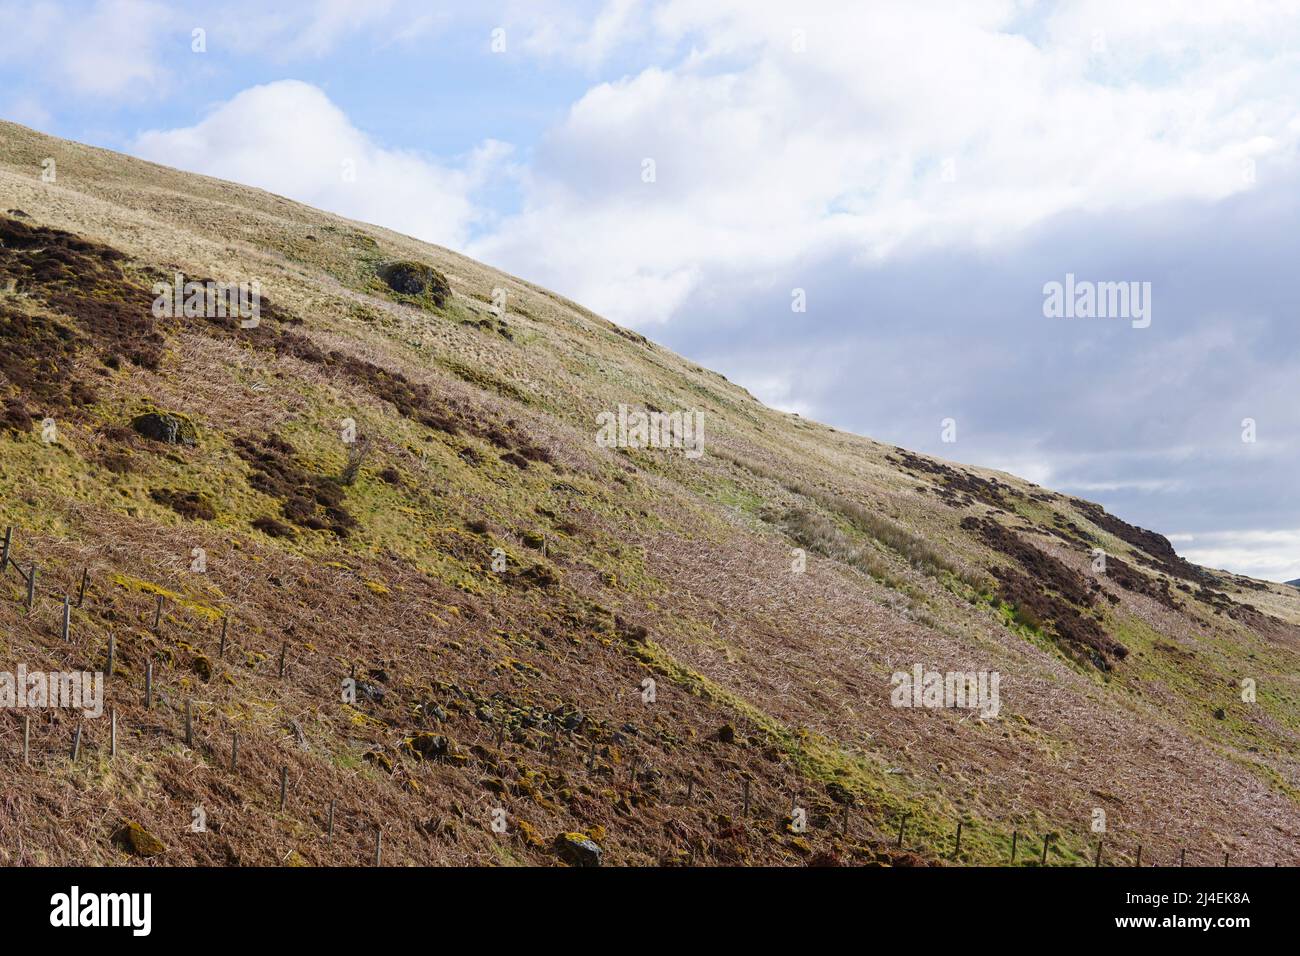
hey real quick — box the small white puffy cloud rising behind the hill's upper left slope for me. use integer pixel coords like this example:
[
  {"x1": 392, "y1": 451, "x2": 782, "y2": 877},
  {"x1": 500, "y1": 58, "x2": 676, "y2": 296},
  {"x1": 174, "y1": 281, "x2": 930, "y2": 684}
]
[{"x1": 133, "y1": 81, "x2": 510, "y2": 248}]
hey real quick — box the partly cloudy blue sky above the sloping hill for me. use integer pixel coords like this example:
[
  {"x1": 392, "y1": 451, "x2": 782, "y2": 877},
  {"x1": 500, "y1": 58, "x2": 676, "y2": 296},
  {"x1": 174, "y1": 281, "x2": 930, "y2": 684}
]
[{"x1": 0, "y1": 0, "x2": 1300, "y2": 580}]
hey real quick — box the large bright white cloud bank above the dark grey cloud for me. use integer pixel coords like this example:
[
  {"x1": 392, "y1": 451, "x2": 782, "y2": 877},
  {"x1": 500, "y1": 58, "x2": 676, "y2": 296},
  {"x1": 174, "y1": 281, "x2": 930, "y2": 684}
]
[{"x1": 472, "y1": 0, "x2": 1300, "y2": 325}]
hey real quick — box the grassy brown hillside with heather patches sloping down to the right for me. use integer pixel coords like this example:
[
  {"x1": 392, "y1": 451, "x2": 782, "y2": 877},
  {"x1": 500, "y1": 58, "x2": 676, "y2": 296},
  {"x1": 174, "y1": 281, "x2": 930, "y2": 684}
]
[{"x1": 0, "y1": 117, "x2": 1300, "y2": 865}]
